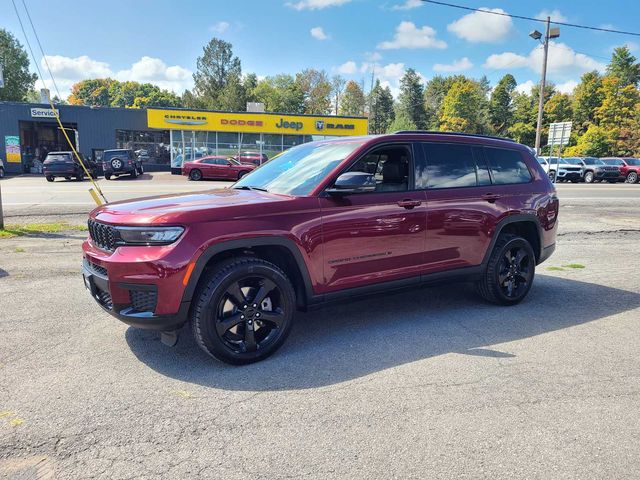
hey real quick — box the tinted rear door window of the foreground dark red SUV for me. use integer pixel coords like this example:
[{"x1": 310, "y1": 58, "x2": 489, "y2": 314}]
[{"x1": 416, "y1": 143, "x2": 477, "y2": 188}]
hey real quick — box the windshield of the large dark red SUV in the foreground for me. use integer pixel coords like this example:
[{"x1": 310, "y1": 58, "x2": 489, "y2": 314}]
[{"x1": 233, "y1": 141, "x2": 362, "y2": 195}]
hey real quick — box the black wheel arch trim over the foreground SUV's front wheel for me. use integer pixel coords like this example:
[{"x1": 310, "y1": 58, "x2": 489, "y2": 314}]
[{"x1": 182, "y1": 237, "x2": 313, "y2": 308}]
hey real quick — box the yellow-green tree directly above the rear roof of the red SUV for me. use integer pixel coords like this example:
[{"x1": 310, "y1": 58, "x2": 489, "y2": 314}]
[{"x1": 440, "y1": 79, "x2": 487, "y2": 133}]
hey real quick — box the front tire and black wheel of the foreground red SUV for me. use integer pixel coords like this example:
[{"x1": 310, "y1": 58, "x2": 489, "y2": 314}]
[{"x1": 191, "y1": 256, "x2": 296, "y2": 365}]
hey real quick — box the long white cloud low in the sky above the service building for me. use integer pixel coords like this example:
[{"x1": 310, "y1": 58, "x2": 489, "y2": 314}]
[{"x1": 36, "y1": 55, "x2": 193, "y2": 98}]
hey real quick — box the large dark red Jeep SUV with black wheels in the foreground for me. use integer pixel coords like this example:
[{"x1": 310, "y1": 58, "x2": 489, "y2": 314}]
[{"x1": 83, "y1": 132, "x2": 559, "y2": 364}]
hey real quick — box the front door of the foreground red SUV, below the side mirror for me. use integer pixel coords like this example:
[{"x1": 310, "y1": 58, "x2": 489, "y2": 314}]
[{"x1": 320, "y1": 144, "x2": 426, "y2": 292}]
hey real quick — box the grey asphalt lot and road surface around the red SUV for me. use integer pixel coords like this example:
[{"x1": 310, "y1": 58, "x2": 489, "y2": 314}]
[{"x1": 0, "y1": 174, "x2": 640, "y2": 479}]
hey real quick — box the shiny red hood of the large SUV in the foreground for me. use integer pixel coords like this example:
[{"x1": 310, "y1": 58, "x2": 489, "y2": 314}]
[{"x1": 91, "y1": 188, "x2": 295, "y2": 225}]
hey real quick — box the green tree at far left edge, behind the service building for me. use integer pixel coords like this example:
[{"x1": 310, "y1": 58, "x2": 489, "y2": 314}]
[{"x1": 0, "y1": 28, "x2": 38, "y2": 102}]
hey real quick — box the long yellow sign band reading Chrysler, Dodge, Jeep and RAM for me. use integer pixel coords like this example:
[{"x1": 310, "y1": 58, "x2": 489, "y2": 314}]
[{"x1": 147, "y1": 109, "x2": 368, "y2": 136}]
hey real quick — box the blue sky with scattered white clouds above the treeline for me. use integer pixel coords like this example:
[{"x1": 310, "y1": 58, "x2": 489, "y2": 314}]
[{"x1": 5, "y1": 0, "x2": 640, "y2": 99}]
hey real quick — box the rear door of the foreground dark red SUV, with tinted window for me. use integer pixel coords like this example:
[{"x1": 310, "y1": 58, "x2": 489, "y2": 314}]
[{"x1": 416, "y1": 142, "x2": 506, "y2": 273}]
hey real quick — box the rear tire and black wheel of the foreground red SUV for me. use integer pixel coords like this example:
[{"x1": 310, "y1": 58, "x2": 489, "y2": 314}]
[{"x1": 477, "y1": 234, "x2": 536, "y2": 305}]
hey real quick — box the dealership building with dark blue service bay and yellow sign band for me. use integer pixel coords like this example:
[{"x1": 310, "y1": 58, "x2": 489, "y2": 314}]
[{"x1": 0, "y1": 102, "x2": 368, "y2": 174}]
